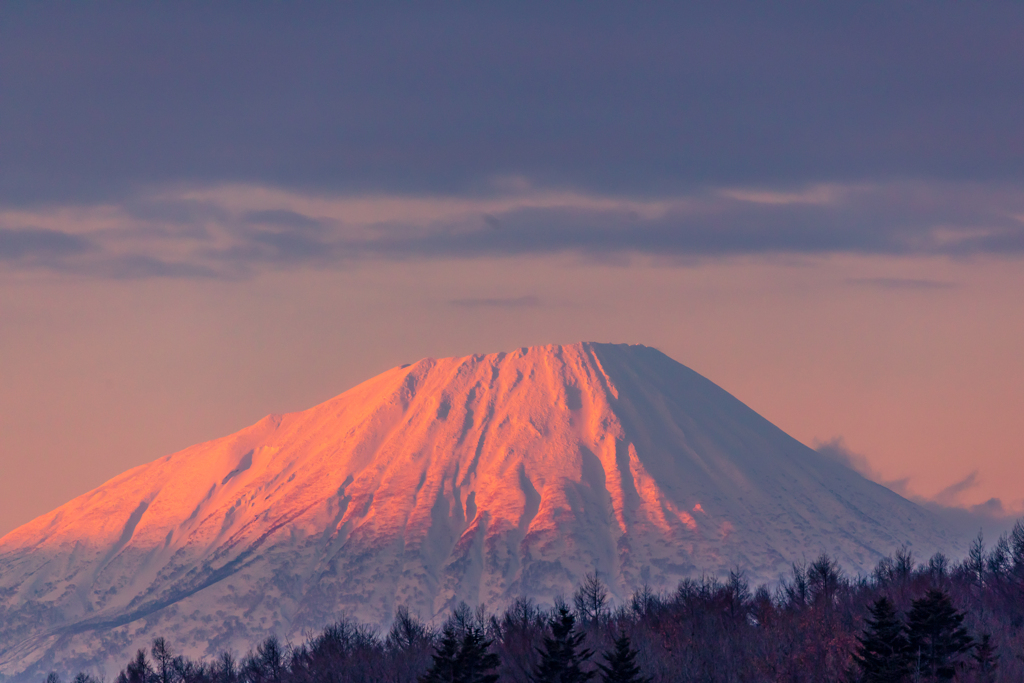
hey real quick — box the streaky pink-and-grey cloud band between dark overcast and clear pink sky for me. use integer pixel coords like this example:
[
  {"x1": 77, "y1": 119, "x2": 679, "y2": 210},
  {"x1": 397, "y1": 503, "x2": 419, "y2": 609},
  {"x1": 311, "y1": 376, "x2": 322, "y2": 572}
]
[{"x1": 6, "y1": 182, "x2": 1024, "y2": 282}]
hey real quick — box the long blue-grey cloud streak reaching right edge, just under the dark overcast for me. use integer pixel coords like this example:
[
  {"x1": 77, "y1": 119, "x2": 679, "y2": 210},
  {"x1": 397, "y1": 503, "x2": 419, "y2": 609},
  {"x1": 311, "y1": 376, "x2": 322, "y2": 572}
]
[{"x1": 311, "y1": 193, "x2": 1024, "y2": 264}]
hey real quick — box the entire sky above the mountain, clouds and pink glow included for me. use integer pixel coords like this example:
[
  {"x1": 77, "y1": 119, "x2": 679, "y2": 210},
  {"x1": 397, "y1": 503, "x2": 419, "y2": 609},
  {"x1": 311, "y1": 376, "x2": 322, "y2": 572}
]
[{"x1": 0, "y1": 2, "x2": 1024, "y2": 533}]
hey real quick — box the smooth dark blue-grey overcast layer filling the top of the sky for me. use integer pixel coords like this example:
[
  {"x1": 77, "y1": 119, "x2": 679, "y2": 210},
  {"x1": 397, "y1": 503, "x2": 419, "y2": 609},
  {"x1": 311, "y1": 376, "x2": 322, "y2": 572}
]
[{"x1": 0, "y1": 1, "x2": 1024, "y2": 205}]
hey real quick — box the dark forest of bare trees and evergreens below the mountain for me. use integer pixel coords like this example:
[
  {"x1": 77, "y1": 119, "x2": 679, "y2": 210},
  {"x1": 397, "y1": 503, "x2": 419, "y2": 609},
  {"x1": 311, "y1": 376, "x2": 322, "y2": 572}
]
[{"x1": 47, "y1": 521, "x2": 1024, "y2": 683}]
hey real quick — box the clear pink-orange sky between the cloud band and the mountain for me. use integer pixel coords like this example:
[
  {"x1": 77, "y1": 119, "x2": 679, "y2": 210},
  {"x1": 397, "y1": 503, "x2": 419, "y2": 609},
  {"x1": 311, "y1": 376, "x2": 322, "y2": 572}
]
[{"x1": 0, "y1": 248, "x2": 1024, "y2": 532}]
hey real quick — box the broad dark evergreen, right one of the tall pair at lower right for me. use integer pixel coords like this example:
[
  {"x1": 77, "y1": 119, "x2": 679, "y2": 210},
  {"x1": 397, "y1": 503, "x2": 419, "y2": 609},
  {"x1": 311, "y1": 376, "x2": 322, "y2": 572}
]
[{"x1": 907, "y1": 589, "x2": 972, "y2": 681}]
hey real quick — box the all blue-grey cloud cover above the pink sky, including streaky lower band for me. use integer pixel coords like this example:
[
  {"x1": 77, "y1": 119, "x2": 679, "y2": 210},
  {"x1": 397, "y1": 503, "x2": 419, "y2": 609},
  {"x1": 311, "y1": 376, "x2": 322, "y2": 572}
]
[{"x1": 0, "y1": 2, "x2": 1024, "y2": 276}]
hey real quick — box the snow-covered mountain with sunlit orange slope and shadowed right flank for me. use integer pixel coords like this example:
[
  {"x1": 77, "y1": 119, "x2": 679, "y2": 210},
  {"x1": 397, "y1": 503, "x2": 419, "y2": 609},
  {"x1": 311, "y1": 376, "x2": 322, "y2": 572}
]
[{"x1": 0, "y1": 343, "x2": 956, "y2": 679}]
